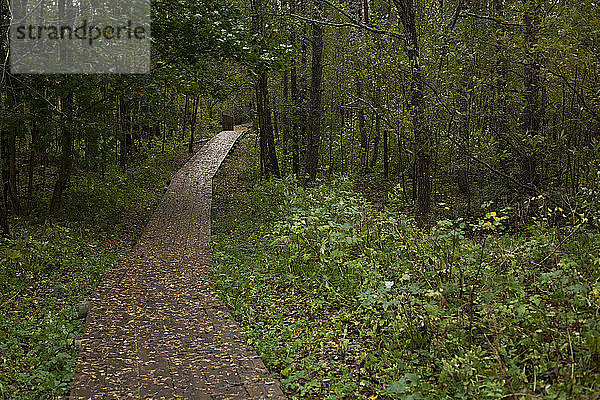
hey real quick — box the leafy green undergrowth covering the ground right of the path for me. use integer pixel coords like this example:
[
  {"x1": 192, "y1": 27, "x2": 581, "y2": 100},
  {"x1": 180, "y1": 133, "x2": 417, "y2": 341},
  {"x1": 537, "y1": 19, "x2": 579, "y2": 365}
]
[{"x1": 213, "y1": 179, "x2": 600, "y2": 399}]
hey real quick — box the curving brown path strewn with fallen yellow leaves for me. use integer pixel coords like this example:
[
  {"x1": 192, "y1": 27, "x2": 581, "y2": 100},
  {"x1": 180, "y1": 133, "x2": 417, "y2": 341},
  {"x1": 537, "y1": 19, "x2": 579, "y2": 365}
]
[{"x1": 71, "y1": 127, "x2": 285, "y2": 400}]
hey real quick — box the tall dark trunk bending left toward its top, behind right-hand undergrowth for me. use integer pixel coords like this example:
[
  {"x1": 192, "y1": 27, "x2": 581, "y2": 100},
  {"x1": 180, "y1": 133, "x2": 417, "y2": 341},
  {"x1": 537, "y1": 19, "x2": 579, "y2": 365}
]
[{"x1": 394, "y1": 0, "x2": 432, "y2": 226}]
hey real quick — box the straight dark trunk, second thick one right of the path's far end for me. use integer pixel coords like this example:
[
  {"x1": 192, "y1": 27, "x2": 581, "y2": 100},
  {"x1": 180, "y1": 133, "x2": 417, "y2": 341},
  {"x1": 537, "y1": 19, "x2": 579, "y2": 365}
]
[{"x1": 306, "y1": 17, "x2": 323, "y2": 182}]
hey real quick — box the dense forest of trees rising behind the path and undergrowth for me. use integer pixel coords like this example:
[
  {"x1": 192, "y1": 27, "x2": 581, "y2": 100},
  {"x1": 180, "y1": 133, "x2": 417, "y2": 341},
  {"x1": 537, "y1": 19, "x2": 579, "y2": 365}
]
[{"x1": 2, "y1": 1, "x2": 599, "y2": 229}]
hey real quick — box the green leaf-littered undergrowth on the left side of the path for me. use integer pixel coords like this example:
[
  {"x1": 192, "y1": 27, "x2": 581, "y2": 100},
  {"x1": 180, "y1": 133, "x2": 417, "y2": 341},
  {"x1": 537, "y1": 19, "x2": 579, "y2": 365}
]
[{"x1": 0, "y1": 145, "x2": 181, "y2": 400}]
